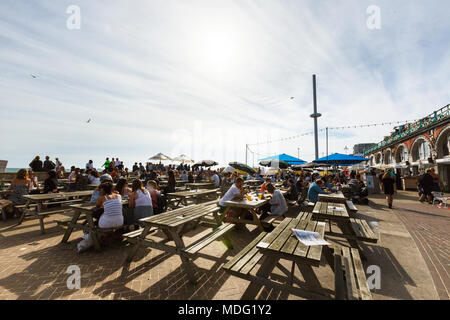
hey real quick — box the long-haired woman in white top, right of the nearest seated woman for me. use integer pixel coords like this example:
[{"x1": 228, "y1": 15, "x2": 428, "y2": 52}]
[{"x1": 128, "y1": 179, "x2": 153, "y2": 227}]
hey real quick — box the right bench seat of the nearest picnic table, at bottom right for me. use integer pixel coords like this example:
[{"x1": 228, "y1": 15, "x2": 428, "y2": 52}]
[{"x1": 334, "y1": 246, "x2": 372, "y2": 300}]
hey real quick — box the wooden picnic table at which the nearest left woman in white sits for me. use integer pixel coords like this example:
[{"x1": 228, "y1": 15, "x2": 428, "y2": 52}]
[{"x1": 56, "y1": 200, "x2": 128, "y2": 251}]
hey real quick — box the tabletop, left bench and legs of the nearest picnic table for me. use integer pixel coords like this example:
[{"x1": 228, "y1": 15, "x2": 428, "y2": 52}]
[{"x1": 222, "y1": 214, "x2": 334, "y2": 299}]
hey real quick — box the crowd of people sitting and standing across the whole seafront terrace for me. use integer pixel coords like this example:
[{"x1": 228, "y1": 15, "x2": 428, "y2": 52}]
[{"x1": 4, "y1": 156, "x2": 446, "y2": 234}]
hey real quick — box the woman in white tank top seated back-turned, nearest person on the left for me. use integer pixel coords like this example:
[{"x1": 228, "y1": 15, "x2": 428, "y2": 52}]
[{"x1": 96, "y1": 181, "x2": 123, "y2": 229}]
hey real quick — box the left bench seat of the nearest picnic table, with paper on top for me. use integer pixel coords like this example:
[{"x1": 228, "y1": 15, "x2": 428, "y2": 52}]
[{"x1": 222, "y1": 232, "x2": 267, "y2": 276}]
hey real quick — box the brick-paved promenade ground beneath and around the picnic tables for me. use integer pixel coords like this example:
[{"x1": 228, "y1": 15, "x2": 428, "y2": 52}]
[{"x1": 0, "y1": 192, "x2": 450, "y2": 299}]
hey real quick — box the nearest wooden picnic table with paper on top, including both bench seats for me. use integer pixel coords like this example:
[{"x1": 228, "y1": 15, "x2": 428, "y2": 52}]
[{"x1": 222, "y1": 213, "x2": 372, "y2": 300}]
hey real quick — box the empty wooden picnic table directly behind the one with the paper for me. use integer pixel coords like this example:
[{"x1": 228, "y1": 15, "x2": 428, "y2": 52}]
[{"x1": 312, "y1": 201, "x2": 378, "y2": 259}]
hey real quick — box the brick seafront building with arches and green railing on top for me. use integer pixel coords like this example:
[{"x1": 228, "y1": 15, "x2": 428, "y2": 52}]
[{"x1": 363, "y1": 105, "x2": 450, "y2": 191}]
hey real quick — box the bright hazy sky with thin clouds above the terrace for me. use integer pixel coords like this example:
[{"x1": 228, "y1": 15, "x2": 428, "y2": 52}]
[{"x1": 0, "y1": 0, "x2": 450, "y2": 168}]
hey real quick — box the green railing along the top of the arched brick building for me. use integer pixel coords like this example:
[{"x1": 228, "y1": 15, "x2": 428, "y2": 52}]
[{"x1": 363, "y1": 104, "x2": 450, "y2": 155}]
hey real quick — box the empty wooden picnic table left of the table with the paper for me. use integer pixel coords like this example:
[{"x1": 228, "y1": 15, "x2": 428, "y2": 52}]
[{"x1": 124, "y1": 202, "x2": 235, "y2": 283}]
